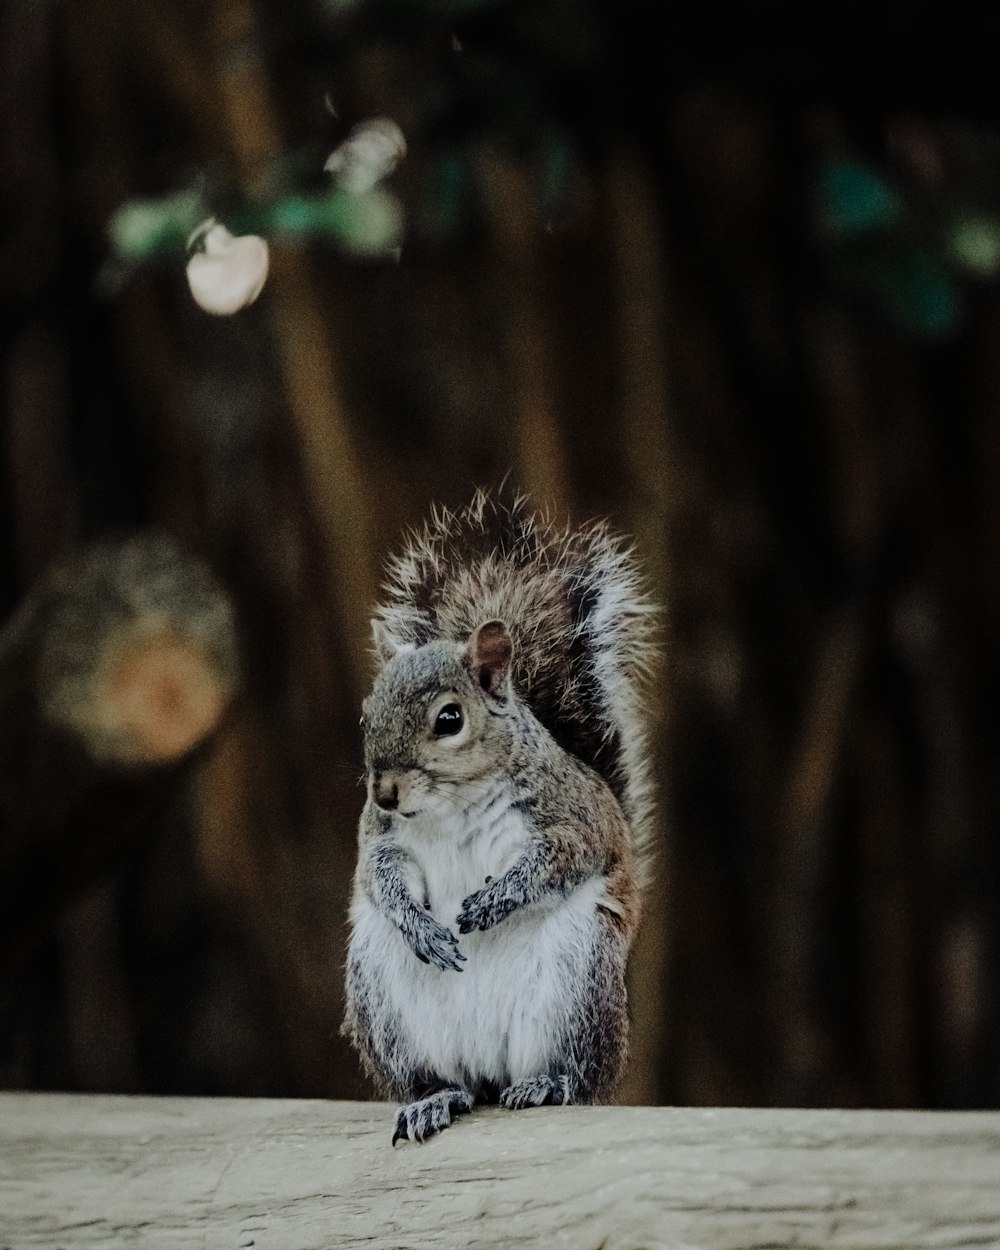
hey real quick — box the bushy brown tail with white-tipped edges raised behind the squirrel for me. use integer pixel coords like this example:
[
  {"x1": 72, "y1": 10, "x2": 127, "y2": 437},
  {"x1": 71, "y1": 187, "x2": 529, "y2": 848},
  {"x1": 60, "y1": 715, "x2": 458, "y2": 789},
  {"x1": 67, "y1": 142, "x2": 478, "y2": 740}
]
[{"x1": 376, "y1": 490, "x2": 656, "y2": 880}]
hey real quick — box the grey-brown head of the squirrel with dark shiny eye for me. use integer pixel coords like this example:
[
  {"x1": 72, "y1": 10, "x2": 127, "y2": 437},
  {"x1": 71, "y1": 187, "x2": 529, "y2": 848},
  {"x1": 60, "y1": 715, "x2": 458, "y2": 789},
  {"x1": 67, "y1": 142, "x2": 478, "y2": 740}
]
[{"x1": 363, "y1": 620, "x2": 514, "y2": 818}]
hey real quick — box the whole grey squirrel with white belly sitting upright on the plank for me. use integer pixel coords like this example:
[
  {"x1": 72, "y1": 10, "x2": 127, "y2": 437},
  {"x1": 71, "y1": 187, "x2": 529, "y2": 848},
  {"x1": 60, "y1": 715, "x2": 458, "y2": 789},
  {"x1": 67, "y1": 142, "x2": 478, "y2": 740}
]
[{"x1": 344, "y1": 490, "x2": 656, "y2": 1145}]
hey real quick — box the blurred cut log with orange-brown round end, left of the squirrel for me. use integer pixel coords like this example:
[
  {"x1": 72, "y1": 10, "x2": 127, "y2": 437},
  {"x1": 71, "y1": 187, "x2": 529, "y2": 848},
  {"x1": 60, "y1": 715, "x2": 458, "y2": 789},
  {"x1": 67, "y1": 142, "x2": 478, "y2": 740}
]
[{"x1": 0, "y1": 535, "x2": 238, "y2": 964}]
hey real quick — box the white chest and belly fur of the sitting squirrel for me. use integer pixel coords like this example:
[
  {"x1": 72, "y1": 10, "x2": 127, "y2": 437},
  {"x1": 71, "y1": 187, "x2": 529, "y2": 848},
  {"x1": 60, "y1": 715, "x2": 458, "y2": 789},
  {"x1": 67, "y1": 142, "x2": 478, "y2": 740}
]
[{"x1": 351, "y1": 795, "x2": 605, "y2": 1086}]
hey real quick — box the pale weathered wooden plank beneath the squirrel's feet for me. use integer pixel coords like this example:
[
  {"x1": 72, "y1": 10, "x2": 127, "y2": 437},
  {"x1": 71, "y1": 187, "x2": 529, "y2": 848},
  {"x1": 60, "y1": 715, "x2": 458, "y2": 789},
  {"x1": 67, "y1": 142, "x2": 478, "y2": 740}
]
[{"x1": 0, "y1": 1094, "x2": 1000, "y2": 1250}]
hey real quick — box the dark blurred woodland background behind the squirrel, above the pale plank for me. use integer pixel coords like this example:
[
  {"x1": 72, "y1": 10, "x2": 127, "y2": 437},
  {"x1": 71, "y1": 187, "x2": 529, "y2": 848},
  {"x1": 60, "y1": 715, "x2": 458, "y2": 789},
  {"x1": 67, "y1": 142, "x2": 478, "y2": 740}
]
[{"x1": 0, "y1": 0, "x2": 1000, "y2": 1108}]
